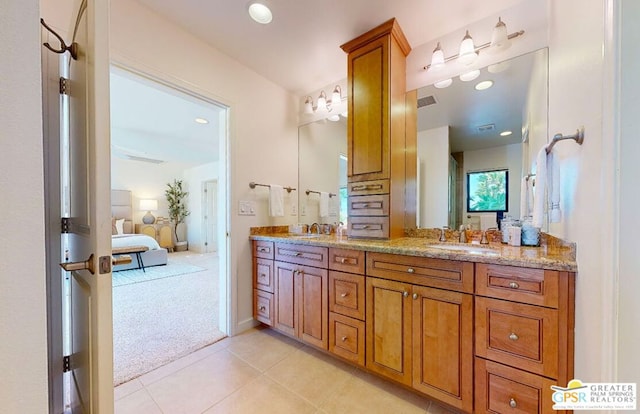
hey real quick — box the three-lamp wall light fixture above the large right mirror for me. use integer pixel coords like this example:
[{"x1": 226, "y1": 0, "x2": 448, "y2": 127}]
[{"x1": 423, "y1": 17, "x2": 524, "y2": 87}]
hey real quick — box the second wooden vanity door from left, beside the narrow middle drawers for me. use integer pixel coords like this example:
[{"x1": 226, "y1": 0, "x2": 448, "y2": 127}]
[{"x1": 295, "y1": 266, "x2": 329, "y2": 349}]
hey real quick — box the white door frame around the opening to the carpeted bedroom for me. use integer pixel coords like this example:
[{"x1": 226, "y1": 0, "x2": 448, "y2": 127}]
[{"x1": 111, "y1": 59, "x2": 232, "y2": 336}]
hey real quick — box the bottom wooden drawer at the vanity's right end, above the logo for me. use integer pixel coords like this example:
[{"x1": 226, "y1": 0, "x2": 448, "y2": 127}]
[{"x1": 475, "y1": 358, "x2": 564, "y2": 414}]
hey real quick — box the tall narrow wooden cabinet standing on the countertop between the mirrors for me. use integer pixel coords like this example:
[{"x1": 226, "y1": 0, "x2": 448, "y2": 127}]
[{"x1": 341, "y1": 19, "x2": 416, "y2": 238}]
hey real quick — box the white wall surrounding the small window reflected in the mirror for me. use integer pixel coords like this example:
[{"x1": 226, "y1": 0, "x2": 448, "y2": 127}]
[{"x1": 461, "y1": 144, "x2": 522, "y2": 226}]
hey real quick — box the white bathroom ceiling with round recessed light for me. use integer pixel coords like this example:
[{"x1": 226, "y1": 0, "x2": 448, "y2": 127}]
[{"x1": 138, "y1": 0, "x2": 522, "y2": 96}]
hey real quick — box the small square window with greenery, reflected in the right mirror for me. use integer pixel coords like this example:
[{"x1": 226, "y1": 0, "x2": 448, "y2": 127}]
[{"x1": 467, "y1": 170, "x2": 509, "y2": 213}]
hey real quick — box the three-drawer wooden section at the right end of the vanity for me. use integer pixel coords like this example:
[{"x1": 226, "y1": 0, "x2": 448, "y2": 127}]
[{"x1": 475, "y1": 263, "x2": 575, "y2": 413}]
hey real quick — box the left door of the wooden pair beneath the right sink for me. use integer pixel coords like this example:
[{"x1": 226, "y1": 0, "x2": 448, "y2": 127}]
[{"x1": 366, "y1": 277, "x2": 412, "y2": 385}]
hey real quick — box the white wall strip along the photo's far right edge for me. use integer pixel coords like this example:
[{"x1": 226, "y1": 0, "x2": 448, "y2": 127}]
[{"x1": 616, "y1": 0, "x2": 640, "y2": 382}]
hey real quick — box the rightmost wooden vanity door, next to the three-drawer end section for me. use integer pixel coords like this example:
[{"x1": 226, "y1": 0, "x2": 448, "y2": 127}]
[{"x1": 412, "y1": 286, "x2": 473, "y2": 412}]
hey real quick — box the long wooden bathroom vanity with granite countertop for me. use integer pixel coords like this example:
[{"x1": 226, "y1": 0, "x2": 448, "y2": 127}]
[{"x1": 251, "y1": 233, "x2": 577, "y2": 413}]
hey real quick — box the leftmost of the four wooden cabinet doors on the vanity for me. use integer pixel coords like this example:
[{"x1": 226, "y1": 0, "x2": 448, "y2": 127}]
[{"x1": 274, "y1": 262, "x2": 298, "y2": 336}]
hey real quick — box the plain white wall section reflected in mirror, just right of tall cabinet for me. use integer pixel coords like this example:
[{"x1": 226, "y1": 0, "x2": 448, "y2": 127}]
[{"x1": 417, "y1": 126, "x2": 450, "y2": 228}]
